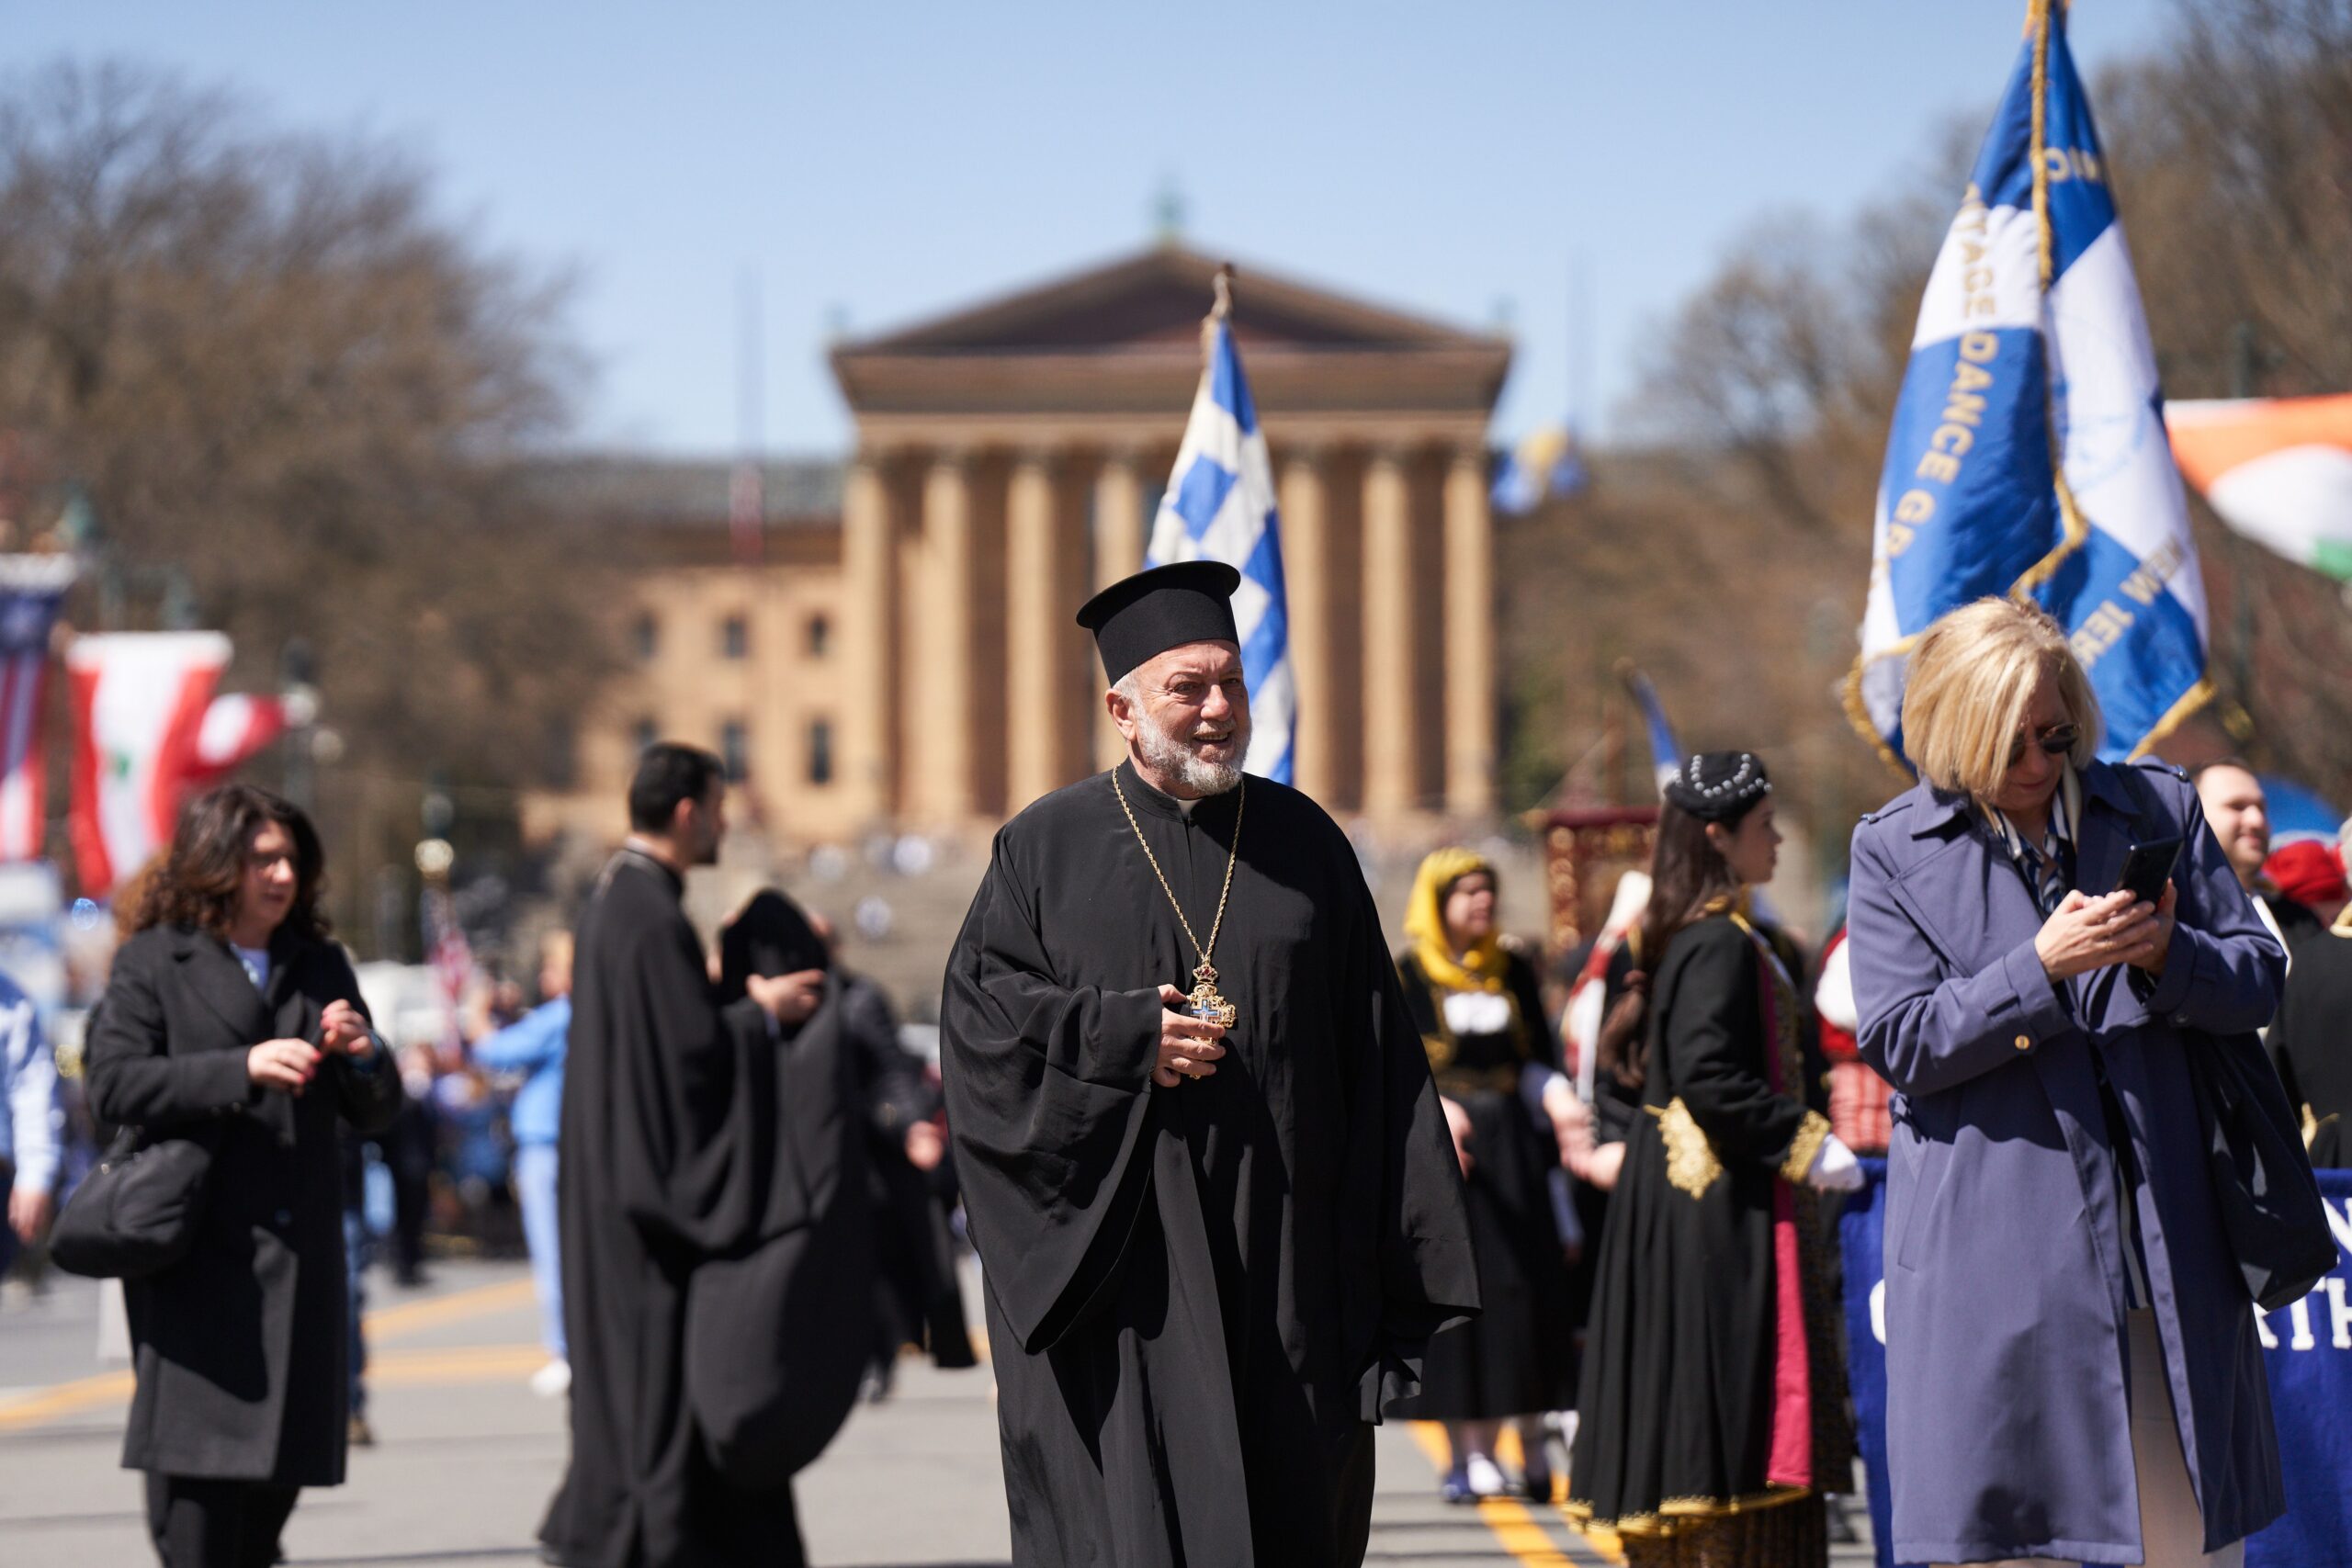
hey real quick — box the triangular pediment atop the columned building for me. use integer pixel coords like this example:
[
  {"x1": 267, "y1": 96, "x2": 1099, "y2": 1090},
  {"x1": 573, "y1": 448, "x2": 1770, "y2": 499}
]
[{"x1": 840, "y1": 244, "x2": 1496, "y2": 355}]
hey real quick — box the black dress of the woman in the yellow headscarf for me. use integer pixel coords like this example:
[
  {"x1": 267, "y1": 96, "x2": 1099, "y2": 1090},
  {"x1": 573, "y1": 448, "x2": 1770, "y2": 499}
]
[{"x1": 1390, "y1": 952, "x2": 1576, "y2": 1420}]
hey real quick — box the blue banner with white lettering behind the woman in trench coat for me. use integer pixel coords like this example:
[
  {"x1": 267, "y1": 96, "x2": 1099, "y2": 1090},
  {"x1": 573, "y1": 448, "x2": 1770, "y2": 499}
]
[{"x1": 1837, "y1": 1159, "x2": 2352, "y2": 1568}]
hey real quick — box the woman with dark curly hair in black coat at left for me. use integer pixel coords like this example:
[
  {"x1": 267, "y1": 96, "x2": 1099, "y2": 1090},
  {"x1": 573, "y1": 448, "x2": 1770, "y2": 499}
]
[{"x1": 89, "y1": 785, "x2": 400, "y2": 1568}]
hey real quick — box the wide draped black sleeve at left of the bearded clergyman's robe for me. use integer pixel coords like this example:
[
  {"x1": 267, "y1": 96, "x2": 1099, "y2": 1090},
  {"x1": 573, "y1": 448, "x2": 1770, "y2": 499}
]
[{"x1": 938, "y1": 832, "x2": 1161, "y2": 1352}]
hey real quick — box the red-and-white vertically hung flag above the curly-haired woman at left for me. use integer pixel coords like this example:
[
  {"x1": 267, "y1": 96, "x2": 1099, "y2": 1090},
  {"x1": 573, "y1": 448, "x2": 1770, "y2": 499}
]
[{"x1": 66, "y1": 632, "x2": 228, "y2": 898}]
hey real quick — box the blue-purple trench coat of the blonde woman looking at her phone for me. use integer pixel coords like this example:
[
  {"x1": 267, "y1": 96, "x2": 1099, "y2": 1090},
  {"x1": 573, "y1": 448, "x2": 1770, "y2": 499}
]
[{"x1": 1847, "y1": 761, "x2": 2286, "y2": 1563}]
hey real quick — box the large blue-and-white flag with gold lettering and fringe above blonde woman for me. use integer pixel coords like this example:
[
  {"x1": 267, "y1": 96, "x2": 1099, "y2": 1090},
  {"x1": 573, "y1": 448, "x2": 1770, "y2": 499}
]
[{"x1": 1847, "y1": 0, "x2": 2211, "y2": 760}]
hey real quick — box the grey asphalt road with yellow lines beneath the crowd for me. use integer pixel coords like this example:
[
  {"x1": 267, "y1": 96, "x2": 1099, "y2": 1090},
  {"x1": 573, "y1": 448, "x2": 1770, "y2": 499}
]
[{"x1": 0, "y1": 1262, "x2": 1868, "y2": 1568}]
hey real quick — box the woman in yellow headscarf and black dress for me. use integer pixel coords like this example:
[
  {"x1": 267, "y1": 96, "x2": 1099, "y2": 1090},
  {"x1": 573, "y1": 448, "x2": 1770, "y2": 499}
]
[{"x1": 1393, "y1": 849, "x2": 1576, "y2": 1502}]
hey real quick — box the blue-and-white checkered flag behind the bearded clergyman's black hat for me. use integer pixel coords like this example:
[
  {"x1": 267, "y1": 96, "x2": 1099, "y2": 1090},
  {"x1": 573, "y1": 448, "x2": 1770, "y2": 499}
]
[{"x1": 1143, "y1": 315, "x2": 1298, "y2": 783}]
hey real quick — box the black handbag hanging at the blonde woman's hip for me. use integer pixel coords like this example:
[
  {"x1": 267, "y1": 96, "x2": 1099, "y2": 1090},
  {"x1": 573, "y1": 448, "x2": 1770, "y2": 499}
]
[{"x1": 2183, "y1": 1030, "x2": 2335, "y2": 1312}]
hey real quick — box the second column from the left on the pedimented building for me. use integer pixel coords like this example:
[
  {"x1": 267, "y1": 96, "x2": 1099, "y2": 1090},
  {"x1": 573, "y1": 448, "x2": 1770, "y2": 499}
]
[{"x1": 908, "y1": 451, "x2": 974, "y2": 825}]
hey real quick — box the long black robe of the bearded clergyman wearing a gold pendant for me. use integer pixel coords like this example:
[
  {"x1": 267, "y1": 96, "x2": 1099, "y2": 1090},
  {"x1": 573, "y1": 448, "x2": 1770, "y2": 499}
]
[{"x1": 941, "y1": 764, "x2": 1477, "y2": 1568}]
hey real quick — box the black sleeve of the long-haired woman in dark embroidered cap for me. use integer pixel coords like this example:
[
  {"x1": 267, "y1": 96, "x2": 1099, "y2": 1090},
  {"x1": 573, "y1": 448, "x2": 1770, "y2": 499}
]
[{"x1": 1658, "y1": 919, "x2": 1809, "y2": 1173}]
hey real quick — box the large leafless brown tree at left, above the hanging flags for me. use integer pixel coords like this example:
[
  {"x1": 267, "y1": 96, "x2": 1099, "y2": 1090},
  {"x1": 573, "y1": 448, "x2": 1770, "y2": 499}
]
[{"x1": 0, "y1": 63, "x2": 606, "y2": 907}]
